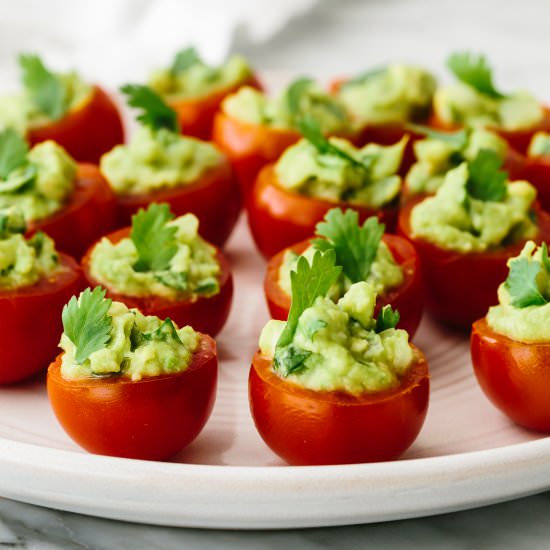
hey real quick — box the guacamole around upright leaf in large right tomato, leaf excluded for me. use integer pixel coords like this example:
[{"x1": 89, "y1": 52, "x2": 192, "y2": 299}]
[{"x1": 410, "y1": 163, "x2": 537, "y2": 253}]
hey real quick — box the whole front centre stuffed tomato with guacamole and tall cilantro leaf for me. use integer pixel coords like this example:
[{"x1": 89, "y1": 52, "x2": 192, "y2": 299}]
[{"x1": 249, "y1": 250, "x2": 429, "y2": 465}]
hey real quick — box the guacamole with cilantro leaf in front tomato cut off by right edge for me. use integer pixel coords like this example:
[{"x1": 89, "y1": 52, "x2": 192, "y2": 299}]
[{"x1": 487, "y1": 241, "x2": 550, "y2": 343}]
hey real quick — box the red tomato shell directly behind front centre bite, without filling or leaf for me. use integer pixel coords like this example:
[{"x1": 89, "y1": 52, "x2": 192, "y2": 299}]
[{"x1": 264, "y1": 234, "x2": 424, "y2": 338}]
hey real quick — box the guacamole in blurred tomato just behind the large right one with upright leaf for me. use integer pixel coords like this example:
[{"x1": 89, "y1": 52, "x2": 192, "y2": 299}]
[{"x1": 407, "y1": 128, "x2": 508, "y2": 194}]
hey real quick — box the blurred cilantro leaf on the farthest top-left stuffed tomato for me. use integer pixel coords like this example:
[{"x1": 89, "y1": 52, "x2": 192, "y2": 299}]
[{"x1": 19, "y1": 54, "x2": 67, "y2": 120}]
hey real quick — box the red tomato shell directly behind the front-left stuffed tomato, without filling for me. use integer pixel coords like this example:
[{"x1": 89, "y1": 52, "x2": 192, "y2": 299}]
[{"x1": 82, "y1": 227, "x2": 233, "y2": 336}]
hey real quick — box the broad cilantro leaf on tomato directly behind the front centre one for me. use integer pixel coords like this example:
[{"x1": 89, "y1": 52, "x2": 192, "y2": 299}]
[{"x1": 313, "y1": 208, "x2": 385, "y2": 283}]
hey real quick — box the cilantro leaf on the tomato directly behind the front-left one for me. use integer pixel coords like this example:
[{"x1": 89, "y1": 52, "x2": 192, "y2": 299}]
[{"x1": 130, "y1": 203, "x2": 178, "y2": 271}]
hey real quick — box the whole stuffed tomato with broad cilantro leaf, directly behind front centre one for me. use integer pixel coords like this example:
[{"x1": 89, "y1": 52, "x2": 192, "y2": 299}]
[{"x1": 264, "y1": 208, "x2": 424, "y2": 338}]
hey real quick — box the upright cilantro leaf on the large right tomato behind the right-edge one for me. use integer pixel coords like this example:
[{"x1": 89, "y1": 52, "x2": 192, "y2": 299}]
[{"x1": 466, "y1": 149, "x2": 508, "y2": 202}]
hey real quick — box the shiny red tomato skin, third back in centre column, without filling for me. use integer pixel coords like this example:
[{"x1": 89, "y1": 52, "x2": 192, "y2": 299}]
[{"x1": 246, "y1": 164, "x2": 398, "y2": 258}]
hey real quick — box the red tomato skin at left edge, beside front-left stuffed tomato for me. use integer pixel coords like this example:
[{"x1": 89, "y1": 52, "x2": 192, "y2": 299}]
[{"x1": 0, "y1": 254, "x2": 84, "y2": 384}]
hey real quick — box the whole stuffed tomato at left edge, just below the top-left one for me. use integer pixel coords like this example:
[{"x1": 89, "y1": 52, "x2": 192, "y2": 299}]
[{"x1": 0, "y1": 128, "x2": 115, "y2": 258}]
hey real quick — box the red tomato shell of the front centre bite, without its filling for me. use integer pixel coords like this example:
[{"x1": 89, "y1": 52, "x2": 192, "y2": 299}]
[{"x1": 248, "y1": 350, "x2": 430, "y2": 465}]
